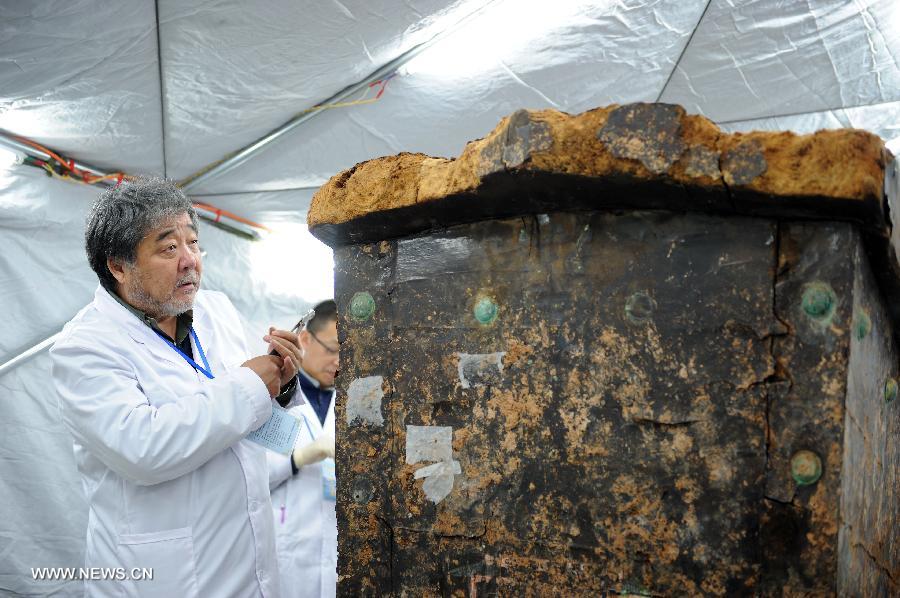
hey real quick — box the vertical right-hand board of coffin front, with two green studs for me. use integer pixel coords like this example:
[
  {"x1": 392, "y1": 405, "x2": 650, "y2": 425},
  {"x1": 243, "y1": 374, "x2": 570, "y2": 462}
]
[{"x1": 762, "y1": 223, "x2": 860, "y2": 596}]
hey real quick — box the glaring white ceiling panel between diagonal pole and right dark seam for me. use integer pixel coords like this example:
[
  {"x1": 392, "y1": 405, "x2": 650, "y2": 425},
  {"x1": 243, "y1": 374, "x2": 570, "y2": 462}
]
[{"x1": 192, "y1": 0, "x2": 705, "y2": 191}]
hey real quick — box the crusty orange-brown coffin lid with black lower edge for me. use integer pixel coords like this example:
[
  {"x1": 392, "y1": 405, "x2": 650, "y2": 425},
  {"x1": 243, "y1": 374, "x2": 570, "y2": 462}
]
[{"x1": 308, "y1": 103, "x2": 900, "y2": 335}]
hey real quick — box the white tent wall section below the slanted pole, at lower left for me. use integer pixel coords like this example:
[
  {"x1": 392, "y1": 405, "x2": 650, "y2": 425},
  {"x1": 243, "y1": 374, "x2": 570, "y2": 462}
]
[{"x1": 0, "y1": 352, "x2": 87, "y2": 596}]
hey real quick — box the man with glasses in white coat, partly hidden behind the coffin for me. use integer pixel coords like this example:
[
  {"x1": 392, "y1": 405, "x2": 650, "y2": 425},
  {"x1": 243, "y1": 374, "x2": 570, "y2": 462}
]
[{"x1": 267, "y1": 300, "x2": 340, "y2": 598}]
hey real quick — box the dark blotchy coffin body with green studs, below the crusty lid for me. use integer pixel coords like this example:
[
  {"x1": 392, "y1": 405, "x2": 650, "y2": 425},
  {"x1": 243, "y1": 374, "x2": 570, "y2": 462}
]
[{"x1": 335, "y1": 212, "x2": 898, "y2": 596}]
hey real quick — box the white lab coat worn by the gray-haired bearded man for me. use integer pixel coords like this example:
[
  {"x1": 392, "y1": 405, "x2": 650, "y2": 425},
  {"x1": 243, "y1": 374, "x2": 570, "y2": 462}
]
[{"x1": 50, "y1": 288, "x2": 279, "y2": 598}]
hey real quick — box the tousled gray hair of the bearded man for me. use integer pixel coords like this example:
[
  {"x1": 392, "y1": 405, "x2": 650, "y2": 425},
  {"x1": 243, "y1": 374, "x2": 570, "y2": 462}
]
[{"x1": 84, "y1": 176, "x2": 198, "y2": 293}]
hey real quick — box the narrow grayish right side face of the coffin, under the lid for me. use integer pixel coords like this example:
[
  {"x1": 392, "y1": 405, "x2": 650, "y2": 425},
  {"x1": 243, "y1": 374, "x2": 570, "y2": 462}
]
[{"x1": 838, "y1": 237, "x2": 900, "y2": 596}]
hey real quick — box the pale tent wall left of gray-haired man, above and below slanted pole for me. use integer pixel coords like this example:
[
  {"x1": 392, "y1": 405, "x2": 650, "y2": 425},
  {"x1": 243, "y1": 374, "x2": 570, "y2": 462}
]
[{"x1": 0, "y1": 169, "x2": 96, "y2": 595}]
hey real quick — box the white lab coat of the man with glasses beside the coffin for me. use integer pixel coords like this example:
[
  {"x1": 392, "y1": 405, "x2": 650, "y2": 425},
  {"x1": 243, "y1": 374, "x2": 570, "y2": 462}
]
[{"x1": 266, "y1": 384, "x2": 337, "y2": 598}]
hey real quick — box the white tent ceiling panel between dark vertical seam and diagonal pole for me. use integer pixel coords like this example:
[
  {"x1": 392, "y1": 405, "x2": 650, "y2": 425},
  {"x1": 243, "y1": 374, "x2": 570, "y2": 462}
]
[{"x1": 159, "y1": 0, "x2": 483, "y2": 180}]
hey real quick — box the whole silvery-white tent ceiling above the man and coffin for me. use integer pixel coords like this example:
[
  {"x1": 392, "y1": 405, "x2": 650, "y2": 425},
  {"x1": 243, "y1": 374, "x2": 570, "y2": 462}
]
[{"x1": 0, "y1": 0, "x2": 900, "y2": 218}]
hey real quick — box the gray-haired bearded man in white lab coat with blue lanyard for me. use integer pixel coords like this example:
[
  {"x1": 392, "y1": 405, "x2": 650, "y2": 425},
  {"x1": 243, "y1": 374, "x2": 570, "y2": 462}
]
[{"x1": 51, "y1": 178, "x2": 300, "y2": 597}]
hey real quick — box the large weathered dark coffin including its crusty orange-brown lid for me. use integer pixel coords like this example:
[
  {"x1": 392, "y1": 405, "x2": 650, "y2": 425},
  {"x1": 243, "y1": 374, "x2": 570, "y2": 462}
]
[{"x1": 310, "y1": 104, "x2": 900, "y2": 596}]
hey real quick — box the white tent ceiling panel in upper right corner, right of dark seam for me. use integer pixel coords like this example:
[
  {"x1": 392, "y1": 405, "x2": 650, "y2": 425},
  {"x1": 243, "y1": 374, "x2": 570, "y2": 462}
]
[{"x1": 662, "y1": 0, "x2": 900, "y2": 121}]
